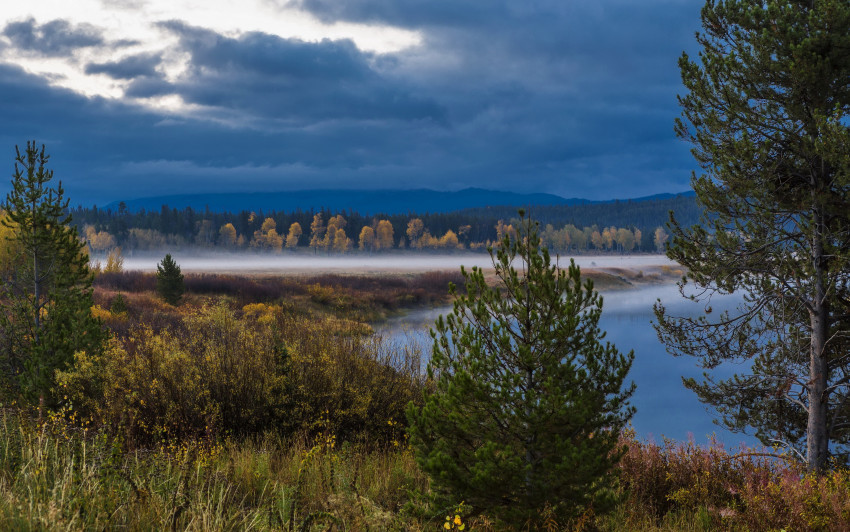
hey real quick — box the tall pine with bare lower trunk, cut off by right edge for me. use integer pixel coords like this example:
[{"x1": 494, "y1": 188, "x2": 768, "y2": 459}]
[{"x1": 657, "y1": 0, "x2": 850, "y2": 471}]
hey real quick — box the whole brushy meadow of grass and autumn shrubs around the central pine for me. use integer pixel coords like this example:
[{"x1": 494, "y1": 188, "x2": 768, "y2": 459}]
[{"x1": 6, "y1": 271, "x2": 850, "y2": 531}]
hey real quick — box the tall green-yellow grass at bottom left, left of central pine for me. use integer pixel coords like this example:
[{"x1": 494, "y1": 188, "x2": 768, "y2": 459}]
[{"x1": 0, "y1": 410, "x2": 427, "y2": 530}]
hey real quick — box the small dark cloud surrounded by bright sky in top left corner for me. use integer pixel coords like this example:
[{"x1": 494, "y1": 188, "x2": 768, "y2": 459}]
[{"x1": 3, "y1": 18, "x2": 104, "y2": 56}]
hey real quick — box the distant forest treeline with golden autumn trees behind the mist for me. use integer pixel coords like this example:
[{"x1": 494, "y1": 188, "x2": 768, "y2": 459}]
[{"x1": 71, "y1": 195, "x2": 699, "y2": 254}]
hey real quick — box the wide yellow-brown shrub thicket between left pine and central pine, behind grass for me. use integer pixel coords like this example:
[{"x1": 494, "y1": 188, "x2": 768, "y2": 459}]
[{"x1": 59, "y1": 303, "x2": 419, "y2": 445}]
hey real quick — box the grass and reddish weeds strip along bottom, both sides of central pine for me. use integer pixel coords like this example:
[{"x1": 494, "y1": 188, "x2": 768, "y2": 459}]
[{"x1": 0, "y1": 409, "x2": 850, "y2": 531}]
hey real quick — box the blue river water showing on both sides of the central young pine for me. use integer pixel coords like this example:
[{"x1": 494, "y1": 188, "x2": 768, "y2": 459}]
[{"x1": 377, "y1": 284, "x2": 758, "y2": 449}]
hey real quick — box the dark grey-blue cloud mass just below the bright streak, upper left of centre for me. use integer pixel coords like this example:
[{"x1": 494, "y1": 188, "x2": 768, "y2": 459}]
[{"x1": 133, "y1": 21, "x2": 443, "y2": 124}]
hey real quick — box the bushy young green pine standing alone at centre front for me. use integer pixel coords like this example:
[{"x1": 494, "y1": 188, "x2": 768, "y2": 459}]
[{"x1": 408, "y1": 213, "x2": 634, "y2": 527}]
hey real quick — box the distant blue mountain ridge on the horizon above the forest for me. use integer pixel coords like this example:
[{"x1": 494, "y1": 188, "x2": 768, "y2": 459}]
[{"x1": 106, "y1": 188, "x2": 693, "y2": 215}]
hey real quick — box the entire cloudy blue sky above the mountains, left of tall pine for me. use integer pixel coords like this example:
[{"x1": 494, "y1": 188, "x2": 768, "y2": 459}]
[{"x1": 0, "y1": 0, "x2": 702, "y2": 205}]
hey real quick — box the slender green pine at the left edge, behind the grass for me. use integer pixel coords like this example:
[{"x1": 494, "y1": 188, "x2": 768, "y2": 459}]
[{"x1": 0, "y1": 141, "x2": 106, "y2": 406}]
